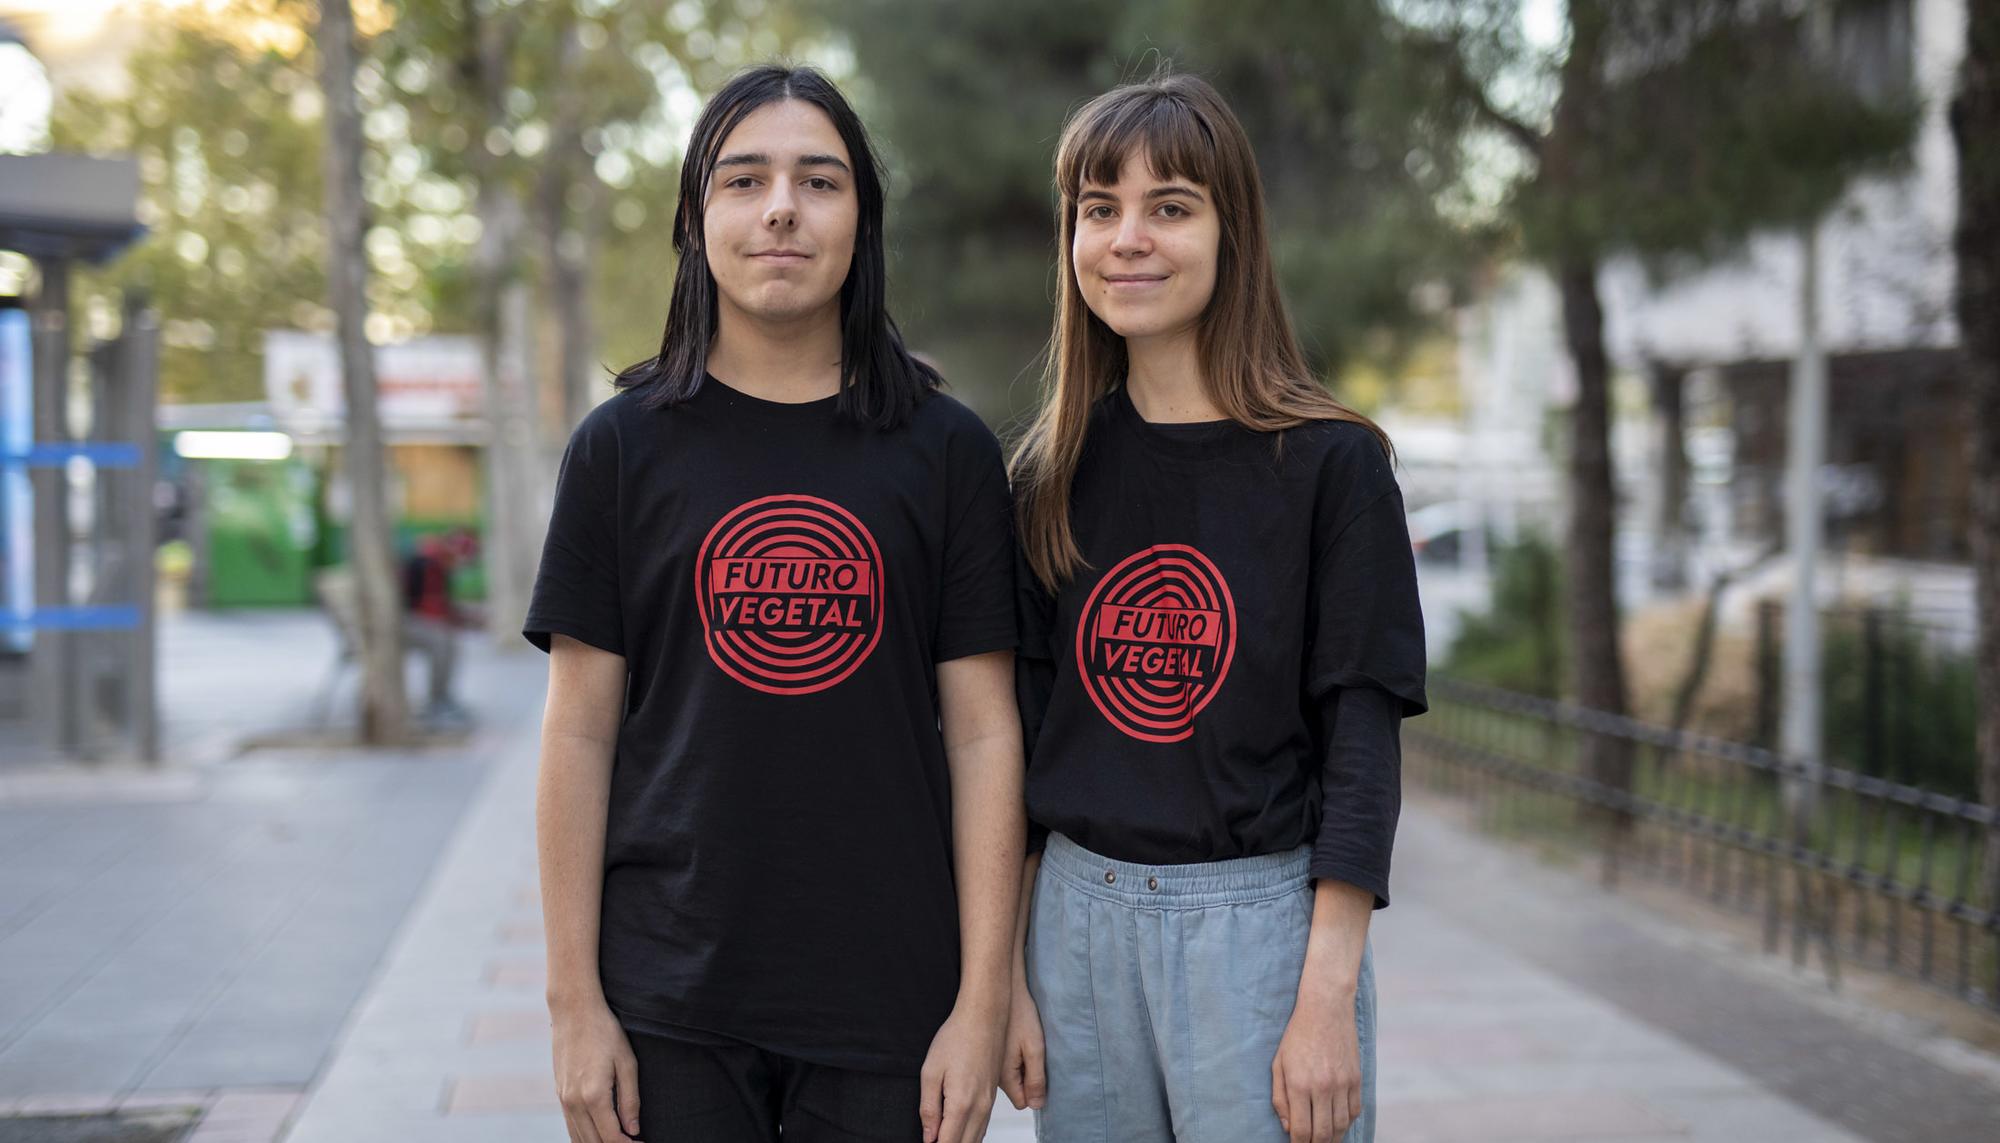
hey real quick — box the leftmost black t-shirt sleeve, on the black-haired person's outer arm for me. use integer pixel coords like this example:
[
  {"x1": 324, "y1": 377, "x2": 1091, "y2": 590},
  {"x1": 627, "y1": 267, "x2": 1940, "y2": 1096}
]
[{"x1": 522, "y1": 408, "x2": 624, "y2": 655}]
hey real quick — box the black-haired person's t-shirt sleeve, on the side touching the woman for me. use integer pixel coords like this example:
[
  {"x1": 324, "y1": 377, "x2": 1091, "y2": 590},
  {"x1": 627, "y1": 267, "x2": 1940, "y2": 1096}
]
[{"x1": 932, "y1": 422, "x2": 1014, "y2": 663}]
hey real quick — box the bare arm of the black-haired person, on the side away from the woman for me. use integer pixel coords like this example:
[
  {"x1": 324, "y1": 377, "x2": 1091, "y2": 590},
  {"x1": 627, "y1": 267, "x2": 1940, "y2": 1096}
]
[{"x1": 536, "y1": 635, "x2": 638, "y2": 1143}]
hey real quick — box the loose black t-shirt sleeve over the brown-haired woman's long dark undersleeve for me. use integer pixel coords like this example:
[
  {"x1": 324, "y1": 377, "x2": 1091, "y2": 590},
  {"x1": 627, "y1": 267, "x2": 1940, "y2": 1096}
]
[{"x1": 1306, "y1": 438, "x2": 1428, "y2": 717}]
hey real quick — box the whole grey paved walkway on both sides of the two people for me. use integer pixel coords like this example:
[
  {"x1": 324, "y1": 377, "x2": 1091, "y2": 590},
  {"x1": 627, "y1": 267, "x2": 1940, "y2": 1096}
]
[{"x1": 11, "y1": 615, "x2": 2000, "y2": 1143}]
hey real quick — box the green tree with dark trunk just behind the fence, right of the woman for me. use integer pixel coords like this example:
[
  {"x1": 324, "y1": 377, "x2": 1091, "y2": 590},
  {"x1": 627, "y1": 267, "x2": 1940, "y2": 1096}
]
[{"x1": 1394, "y1": 0, "x2": 1916, "y2": 803}]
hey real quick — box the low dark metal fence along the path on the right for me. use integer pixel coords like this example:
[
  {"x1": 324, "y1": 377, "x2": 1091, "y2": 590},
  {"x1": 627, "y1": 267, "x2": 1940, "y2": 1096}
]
[{"x1": 1404, "y1": 677, "x2": 2000, "y2": 1009}]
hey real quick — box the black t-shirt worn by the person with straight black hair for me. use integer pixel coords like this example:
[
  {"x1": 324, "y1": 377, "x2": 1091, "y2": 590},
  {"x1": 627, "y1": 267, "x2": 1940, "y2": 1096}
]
[{"x1": 524, "y1": 378, "x2": 1014, "y2": 1073}]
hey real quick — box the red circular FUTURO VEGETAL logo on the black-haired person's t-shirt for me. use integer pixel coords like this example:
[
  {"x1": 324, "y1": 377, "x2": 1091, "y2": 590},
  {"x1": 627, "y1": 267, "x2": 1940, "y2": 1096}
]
[{"x1": 694, "y1": 496, "x2": 882, "y2": 695}]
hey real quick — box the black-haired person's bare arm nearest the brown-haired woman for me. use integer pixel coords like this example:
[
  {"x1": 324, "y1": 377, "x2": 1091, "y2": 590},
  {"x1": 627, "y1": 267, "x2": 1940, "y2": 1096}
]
[{"x1": 918, "y1": 651, "x2": 1026, "y2": 1143}]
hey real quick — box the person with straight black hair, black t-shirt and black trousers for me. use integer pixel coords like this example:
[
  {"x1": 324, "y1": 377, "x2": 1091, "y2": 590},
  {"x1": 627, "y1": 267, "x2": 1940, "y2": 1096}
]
[{"x1": 526, "y1": 66, "x2": 1024, "y2": 1143}]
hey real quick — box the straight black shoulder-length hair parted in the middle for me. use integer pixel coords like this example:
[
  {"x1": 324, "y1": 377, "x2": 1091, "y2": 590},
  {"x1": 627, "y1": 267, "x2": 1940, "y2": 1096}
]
[{"x1": 612, "y1": 64, "x2": 942, "y2": 428}]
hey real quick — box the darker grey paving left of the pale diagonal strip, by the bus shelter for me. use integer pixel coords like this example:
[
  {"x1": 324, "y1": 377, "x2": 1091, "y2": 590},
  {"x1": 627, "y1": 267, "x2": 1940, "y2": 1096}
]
[{"x1": 0, "y1": 611, "x2": 546, "y2": 1143}]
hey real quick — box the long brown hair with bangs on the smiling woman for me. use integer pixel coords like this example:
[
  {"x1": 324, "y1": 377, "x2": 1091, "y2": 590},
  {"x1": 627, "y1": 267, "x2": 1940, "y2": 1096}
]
[{"x1": 1010, "y1": 74, "x2": 1390, "y2": 591}]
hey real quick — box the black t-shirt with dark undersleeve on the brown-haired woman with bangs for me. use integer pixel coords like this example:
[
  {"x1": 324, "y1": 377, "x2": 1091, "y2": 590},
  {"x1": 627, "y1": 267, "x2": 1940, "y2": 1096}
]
[{"x1": 1016, "y1": 388, "x2": 1426, "y2": 905}]
